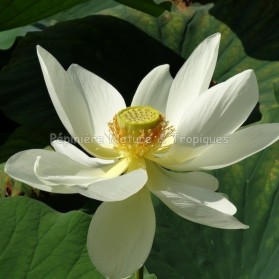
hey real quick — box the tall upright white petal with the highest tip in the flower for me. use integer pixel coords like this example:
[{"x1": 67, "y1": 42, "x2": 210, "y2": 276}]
[{"x1": 166, "y1": 33, "x2": 220, "y2": 127}]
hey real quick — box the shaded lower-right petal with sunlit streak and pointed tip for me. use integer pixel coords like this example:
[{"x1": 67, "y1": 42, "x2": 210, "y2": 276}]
[{"x1": 147, "y1": 162, "x2": 247, "y2": 229}]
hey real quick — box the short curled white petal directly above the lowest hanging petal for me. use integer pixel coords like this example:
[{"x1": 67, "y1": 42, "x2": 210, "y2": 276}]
[{"x1": 75, "y1": 169, "x2": 147, "y2": 201}]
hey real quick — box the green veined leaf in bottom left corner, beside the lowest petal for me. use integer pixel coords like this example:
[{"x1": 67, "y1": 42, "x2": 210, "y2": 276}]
[{"x1": 0, "y1": 197, "x2": 156, "y2": 279}]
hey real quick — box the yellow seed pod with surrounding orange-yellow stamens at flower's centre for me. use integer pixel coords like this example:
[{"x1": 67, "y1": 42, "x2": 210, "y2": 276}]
[{"x1": 109, "y1": 106, "x2": 174, "y2": 162}]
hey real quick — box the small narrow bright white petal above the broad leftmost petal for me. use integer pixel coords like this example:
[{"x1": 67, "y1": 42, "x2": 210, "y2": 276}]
[{"x1": 51, "y1": 140, "x2": 114, "y2": 167}]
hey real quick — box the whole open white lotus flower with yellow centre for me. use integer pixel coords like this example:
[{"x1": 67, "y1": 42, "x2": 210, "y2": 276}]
[{"x1": 5, "y1": 34, "x2": 279, "y2": 279}]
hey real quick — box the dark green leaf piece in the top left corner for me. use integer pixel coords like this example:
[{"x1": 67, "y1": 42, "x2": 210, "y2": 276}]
[{"x1": 0, "y1": 0, "x2": 86, "y2": 31}]
